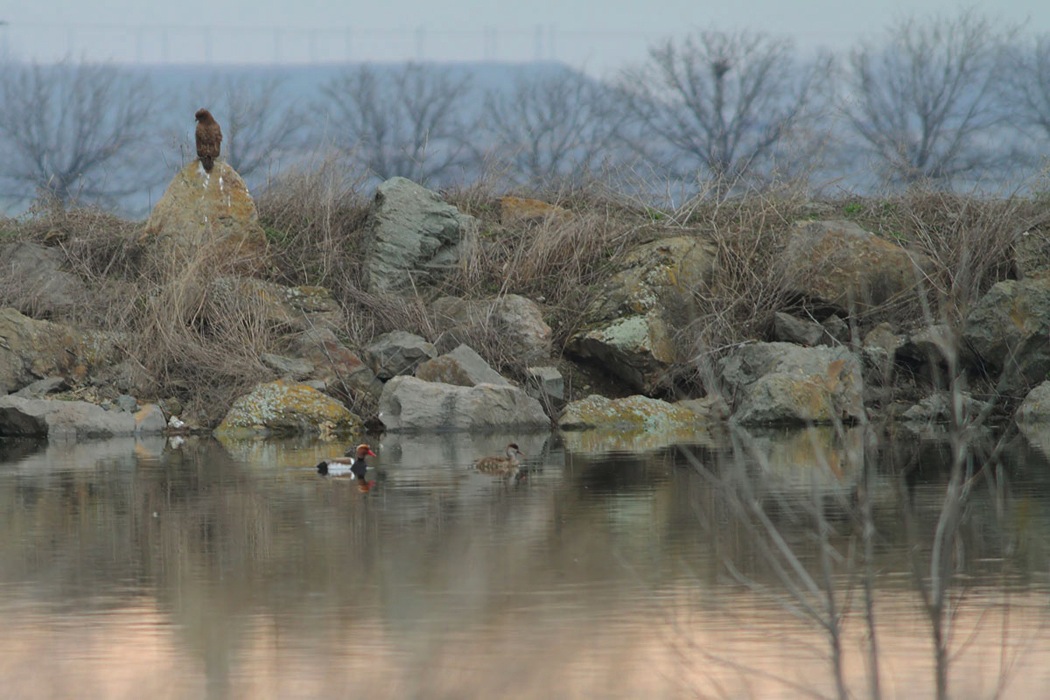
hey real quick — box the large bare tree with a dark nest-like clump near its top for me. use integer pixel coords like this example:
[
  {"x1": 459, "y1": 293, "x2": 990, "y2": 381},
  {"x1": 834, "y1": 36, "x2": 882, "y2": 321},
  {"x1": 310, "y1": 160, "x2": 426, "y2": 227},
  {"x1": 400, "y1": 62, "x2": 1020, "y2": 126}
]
[{"x1": 618, "y1": 31, "x2": 831, "y2": 181}]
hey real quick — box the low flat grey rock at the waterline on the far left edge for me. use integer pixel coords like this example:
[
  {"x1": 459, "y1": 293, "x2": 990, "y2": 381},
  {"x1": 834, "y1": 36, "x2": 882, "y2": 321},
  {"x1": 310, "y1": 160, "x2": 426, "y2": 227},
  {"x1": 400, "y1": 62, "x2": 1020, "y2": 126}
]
[{"x1": 0, "y1": 396, "x2": 165, "y2": 440}]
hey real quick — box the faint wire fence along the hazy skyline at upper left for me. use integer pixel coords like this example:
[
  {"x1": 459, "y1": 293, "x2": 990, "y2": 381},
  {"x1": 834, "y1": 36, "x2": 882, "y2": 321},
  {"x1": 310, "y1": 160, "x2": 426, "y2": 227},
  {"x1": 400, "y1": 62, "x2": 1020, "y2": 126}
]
[{"x1": 0, "y1": 21, "x2": 671, "y2": 70}]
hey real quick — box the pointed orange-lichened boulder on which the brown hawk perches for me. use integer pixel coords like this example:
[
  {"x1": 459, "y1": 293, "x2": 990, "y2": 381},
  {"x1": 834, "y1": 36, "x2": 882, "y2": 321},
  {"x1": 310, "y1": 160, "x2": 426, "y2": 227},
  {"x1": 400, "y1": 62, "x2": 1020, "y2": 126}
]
[{"x1": 145, "y1": 160, "x2": 267, "y2": 273}]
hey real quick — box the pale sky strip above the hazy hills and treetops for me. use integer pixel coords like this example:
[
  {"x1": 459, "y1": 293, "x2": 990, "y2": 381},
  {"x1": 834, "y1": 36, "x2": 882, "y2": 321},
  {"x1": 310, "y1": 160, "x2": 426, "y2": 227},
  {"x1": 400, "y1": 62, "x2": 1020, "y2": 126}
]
[{"x1": 0, "y1": 0, "x2": 1050, "y2": 75}]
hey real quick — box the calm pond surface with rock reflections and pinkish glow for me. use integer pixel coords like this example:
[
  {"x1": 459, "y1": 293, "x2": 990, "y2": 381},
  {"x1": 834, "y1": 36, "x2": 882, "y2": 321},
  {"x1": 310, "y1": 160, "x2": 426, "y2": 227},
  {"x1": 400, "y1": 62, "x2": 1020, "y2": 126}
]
[{"x1": 0, "y1": 423, "x2": 1050, "y2": 698}]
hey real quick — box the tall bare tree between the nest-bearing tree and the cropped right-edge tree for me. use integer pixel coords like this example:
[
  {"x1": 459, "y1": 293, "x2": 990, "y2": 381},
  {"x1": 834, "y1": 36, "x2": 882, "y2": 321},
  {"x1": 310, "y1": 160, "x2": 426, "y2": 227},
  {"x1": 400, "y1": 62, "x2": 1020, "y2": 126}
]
[{"x1": 844, "y1": 10, "x2": 1008, "y2": 184}]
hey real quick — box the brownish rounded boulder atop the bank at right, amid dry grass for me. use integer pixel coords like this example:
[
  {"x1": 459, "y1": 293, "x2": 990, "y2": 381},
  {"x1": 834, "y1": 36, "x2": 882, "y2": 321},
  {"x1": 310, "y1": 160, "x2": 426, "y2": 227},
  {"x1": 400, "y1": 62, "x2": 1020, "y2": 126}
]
[{"x1": 777, "y1": 220, "x2": 932, "y2": 313}]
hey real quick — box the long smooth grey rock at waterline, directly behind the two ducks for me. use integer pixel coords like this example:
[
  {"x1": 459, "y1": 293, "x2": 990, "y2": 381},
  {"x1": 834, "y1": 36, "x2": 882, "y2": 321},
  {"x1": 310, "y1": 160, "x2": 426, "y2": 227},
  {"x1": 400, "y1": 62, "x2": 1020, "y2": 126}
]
[{"x1": 379, "y1": 377, "x2": 550, "y2": 432}]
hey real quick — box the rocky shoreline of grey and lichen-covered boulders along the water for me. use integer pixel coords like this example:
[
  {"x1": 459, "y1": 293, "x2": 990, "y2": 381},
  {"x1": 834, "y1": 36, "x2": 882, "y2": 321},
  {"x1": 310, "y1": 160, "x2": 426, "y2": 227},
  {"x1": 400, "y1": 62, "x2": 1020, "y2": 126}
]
[{"x1": 0, "y1": 162, "x2": 1050, "y2": 440}]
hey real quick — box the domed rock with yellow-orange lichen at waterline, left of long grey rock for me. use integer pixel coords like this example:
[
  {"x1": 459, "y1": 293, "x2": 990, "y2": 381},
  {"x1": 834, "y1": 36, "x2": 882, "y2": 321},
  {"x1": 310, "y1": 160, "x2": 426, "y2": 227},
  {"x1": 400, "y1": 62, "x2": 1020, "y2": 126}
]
[{"x1": 215, "y1": 380, "x2": 362, "y2": 436}]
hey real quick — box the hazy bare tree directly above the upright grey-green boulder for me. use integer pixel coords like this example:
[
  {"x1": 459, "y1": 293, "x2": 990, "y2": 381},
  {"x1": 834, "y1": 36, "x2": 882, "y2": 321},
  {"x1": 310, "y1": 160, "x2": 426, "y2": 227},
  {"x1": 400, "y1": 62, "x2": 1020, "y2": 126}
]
[{"x1": 318, "y1": 63, "x2": 474, "y2": 184}]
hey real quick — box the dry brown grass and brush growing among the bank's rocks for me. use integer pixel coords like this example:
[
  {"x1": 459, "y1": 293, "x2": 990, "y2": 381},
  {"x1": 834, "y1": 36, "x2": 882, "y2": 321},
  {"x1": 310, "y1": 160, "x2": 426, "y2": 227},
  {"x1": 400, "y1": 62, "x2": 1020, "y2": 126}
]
[{"x1": 0, "y1": 172, "x2": 1047, "y2": 420}]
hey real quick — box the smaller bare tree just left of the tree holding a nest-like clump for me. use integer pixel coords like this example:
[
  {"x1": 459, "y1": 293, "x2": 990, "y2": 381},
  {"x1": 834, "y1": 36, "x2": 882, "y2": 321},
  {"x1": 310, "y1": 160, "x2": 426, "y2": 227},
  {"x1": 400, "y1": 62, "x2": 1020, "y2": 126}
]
[{"x1": 483, "y1": 69, "x2": 623, "y2": 183}]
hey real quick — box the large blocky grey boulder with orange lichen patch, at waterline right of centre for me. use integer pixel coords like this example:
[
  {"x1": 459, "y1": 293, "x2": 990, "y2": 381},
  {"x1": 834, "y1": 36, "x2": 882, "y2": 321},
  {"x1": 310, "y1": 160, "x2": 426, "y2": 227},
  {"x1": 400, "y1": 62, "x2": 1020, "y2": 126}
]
[{"x1": 718, "y1": 343, "x2": 864, "y2": 425}]
